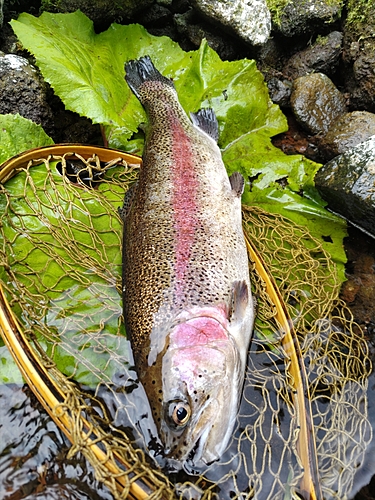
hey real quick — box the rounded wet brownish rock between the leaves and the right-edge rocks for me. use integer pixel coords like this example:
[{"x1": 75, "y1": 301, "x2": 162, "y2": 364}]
[{"x1": 290, "y1": 73, "x2": 347, "y2": 135}]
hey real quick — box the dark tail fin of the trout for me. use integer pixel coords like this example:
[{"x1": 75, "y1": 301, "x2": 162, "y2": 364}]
[{"x1": 125, "y1": 56, "x2": 174, "y2": 99}]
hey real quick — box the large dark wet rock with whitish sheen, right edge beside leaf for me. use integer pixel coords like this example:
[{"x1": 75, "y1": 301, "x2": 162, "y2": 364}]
[{"x1": 315, "y1": 136, "x2": 375, "y2": 236}]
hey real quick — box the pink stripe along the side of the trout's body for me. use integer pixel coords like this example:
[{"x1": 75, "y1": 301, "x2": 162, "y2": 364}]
[{"x1": 169, "y1": 111, "x2": 198, "y2": 303}]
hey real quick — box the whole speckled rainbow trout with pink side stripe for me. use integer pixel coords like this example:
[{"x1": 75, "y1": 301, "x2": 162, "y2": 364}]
[{"x1": 123, "y1": 56, "x2": 254, "y2": 472}]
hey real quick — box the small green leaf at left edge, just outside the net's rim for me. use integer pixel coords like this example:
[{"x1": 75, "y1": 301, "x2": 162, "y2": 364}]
[{"x1": 0, "y1": 114, "x2": 53, "y2": 164}]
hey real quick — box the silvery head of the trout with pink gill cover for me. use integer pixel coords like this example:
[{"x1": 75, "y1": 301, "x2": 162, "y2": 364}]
[{"x1": 160, "y1": 318, "x2": 244, "y2": 473}]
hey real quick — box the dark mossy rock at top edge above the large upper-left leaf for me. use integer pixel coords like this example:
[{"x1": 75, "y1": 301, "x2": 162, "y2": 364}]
[{"x1": 42, "y1": 0, "x2": 153, "y2": 28}]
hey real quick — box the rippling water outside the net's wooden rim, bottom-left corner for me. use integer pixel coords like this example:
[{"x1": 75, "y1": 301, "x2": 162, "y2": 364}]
[{"x1": 0, "y1": 385, "x2": 113, "y2": 500}]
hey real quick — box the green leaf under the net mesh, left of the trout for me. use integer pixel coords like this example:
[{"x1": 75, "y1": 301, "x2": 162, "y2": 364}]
[{"x1": 0, "y1": 162, "x2": 130, "y2": 387}]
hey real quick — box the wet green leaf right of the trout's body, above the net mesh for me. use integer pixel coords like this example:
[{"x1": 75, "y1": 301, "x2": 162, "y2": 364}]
[{"x1": 223, "y1": 131, "x2": 347, "y2": 281}]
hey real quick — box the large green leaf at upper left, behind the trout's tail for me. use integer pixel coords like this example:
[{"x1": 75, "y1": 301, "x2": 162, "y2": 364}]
[{"x1": 11, "y1": 11, "x2": 189, "y2": 146}]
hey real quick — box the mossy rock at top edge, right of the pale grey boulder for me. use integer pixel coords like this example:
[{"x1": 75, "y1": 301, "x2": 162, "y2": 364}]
[{"x1": 269, "y1": 0, "x2": 342, "y2": 37}]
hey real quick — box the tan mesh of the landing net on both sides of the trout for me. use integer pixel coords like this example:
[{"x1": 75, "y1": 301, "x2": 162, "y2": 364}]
[{"x1": 0, "y1": 156, "x2": 372, "y2": 500}]
